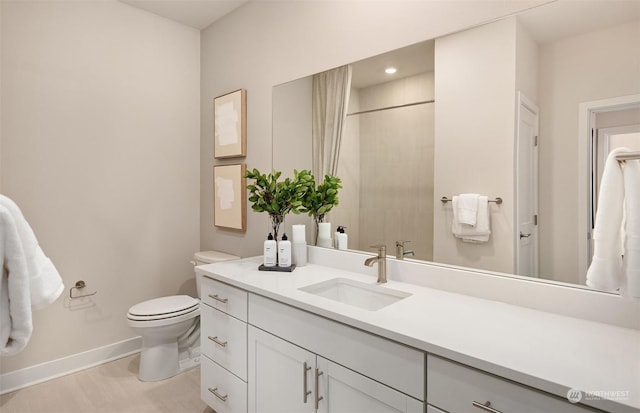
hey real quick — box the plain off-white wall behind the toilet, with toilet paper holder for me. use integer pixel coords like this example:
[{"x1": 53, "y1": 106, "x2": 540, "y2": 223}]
[{"x1": 0, "y1": 1, "x2": 200, "y2": 373}]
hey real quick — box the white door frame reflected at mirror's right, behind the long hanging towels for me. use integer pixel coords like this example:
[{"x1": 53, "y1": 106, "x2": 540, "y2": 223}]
[{"x1": 577, "y1": 94, "x2": 640, "y2": 285}]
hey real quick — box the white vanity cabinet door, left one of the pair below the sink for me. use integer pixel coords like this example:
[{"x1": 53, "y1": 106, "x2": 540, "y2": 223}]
[{"x1": 248, "y1": 326, "x2": 316, "y2": 413}]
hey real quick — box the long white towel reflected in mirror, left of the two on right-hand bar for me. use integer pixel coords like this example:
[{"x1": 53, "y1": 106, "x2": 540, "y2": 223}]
[{"x1": 587, "y1": 148, "x2": 629, "y2": 291}]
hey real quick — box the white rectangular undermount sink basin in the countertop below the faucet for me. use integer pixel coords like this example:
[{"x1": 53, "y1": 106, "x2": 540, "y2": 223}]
[{"x1": 299, "y1": 278, "x2": 411, "y2": 311}]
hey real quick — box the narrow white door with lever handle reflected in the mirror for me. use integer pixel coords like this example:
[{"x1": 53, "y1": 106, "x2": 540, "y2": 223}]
[{"x1": 515, "y1": 92, "x2": 539, "y2": 277}]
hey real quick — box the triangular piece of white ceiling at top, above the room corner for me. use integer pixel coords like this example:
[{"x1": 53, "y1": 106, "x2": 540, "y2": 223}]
[{"x1": 120, "y1": 0, "x2": 250, "y2": 30}]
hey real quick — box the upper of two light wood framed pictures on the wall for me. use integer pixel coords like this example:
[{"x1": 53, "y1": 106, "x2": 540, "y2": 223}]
[{"x1": 213, "y1": 89, "x2": 247, "y2": 159}]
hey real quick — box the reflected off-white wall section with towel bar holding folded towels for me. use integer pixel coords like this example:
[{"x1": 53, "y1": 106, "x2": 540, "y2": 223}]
[{"x1": 434, "y1": 18, "x2": 516, "y2": 273}]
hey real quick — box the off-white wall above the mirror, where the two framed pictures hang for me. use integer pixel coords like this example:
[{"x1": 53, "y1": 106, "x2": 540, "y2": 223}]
[{"x1": 200, "y1": 0, "x2": 547, "y2": 256}]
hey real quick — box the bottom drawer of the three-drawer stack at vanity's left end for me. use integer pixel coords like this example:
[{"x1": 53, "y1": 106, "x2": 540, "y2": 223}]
[{"x1": 200, "y1": 357, "x2": 247, "y2": 413}]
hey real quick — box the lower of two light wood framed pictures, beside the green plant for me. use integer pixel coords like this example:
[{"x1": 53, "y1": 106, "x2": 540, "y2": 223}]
[{"x1": 213, "y1": 163, "x2": 247, "y2": 232}]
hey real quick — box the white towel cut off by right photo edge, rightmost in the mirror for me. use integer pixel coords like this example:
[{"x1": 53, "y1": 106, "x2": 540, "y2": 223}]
[{"x1": 620, "y1": 160, "x2": 640, "y2": 298}]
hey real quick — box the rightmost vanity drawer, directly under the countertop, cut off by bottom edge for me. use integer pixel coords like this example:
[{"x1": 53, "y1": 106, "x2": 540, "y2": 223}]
[{"x1": 427, "y1": 354, "x2": 592, "y2": 413}]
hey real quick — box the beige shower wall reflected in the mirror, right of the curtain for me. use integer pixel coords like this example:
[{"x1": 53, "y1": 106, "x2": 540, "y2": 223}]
[{"x1": 333, "y1": 72, "x2": 434, "y2": 260}]
